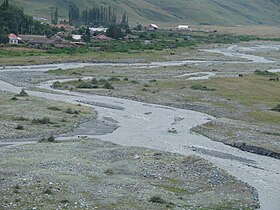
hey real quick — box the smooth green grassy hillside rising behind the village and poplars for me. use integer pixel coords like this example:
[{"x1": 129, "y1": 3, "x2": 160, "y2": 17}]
[{"x1": 8, "y1": 0, "x2": 280, "y2": 25}]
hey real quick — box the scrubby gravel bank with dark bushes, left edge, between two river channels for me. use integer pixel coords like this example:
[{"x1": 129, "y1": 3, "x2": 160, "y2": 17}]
[{"x1": 0, "y1": 92, "x2": 92, "y2": 138}]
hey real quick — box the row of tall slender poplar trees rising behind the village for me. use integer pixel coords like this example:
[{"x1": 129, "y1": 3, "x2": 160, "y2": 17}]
[{"x1": 68, "y1": 4, "x2": 128, "y2": 26}]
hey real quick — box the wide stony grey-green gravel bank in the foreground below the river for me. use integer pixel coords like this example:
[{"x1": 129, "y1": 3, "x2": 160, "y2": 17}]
[{"x1": 0, "y1": 139, "x2": 258, "y2": 209}]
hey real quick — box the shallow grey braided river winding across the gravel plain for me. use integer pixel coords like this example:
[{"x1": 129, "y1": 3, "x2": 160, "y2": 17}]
[{"x1": 0, "y1": 43, "x2": 280, "y2": 210}]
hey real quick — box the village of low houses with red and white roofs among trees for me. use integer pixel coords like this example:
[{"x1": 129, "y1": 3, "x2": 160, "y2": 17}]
[{"x1": 8, "y1": 24, "x2": 192, "y2": 49}]
